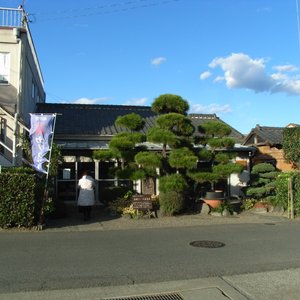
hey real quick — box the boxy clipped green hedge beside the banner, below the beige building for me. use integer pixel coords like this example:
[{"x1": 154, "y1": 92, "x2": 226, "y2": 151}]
[{"x1": 0, "y1": 172, "x2": 38, "y2": 227}]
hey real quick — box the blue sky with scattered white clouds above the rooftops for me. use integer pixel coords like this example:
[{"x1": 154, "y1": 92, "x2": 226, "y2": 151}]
[{"x1": 0, "y1": 0, "x2": 300, "y2": 133}]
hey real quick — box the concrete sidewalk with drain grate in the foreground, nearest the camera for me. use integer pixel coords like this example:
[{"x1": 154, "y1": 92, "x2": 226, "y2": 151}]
[{"x1": 0, "y1": 269, "x2": 300, "y2": 300}]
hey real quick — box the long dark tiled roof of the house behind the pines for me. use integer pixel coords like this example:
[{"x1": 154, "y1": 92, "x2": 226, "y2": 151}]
[{"x1": 37, "y1": 103, "x2": 243, "y2": 141}]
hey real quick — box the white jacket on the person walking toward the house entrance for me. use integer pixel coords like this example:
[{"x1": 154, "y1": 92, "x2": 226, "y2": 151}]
[{"x1": 77, "y1": 175, "x2": 95, "y2": 206}]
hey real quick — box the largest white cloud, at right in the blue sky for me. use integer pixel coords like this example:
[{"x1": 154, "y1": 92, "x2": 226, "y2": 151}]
[{"x1": 209, "y1": 53, "x2": 300, "y2": 95}]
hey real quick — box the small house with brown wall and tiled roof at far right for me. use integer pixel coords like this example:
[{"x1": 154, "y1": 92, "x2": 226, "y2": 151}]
[{"x1": 243, "y1": 124, "x2": 297, "y2": 171}]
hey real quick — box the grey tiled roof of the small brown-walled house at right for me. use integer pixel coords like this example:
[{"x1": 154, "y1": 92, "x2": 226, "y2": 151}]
[{"x1": 243, "y1": 125, "x2": 284, "y2": 145}]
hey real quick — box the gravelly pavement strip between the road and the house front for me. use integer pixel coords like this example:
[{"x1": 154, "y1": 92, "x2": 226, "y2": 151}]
[{"x1": 44, "y1": 207, "x2": 299, "y2": 231}]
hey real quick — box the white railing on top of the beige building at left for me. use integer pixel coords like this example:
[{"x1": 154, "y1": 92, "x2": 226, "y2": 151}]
[{"x1": 0, "y1": 7, "x2": 26, "y2": 27}]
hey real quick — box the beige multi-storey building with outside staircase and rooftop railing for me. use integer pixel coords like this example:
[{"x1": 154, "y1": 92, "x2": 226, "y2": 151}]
[{"x1": 0, "y1": 7, "x2": 45, "y2": 166}]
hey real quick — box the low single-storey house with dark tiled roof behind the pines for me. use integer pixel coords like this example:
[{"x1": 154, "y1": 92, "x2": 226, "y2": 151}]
[{"x1": 37, "y1": 103, "x2": 253, "y2": 201}]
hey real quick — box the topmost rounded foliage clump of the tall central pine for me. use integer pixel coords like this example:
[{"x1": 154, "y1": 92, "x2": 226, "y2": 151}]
[{"x1": 151, "y1": 94, "x2": 189, "y2": 115}]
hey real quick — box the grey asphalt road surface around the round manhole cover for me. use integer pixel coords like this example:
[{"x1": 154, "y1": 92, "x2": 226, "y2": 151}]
[{"x1": 0, "y1": 222, "x2": 300, "y2": 293}]
